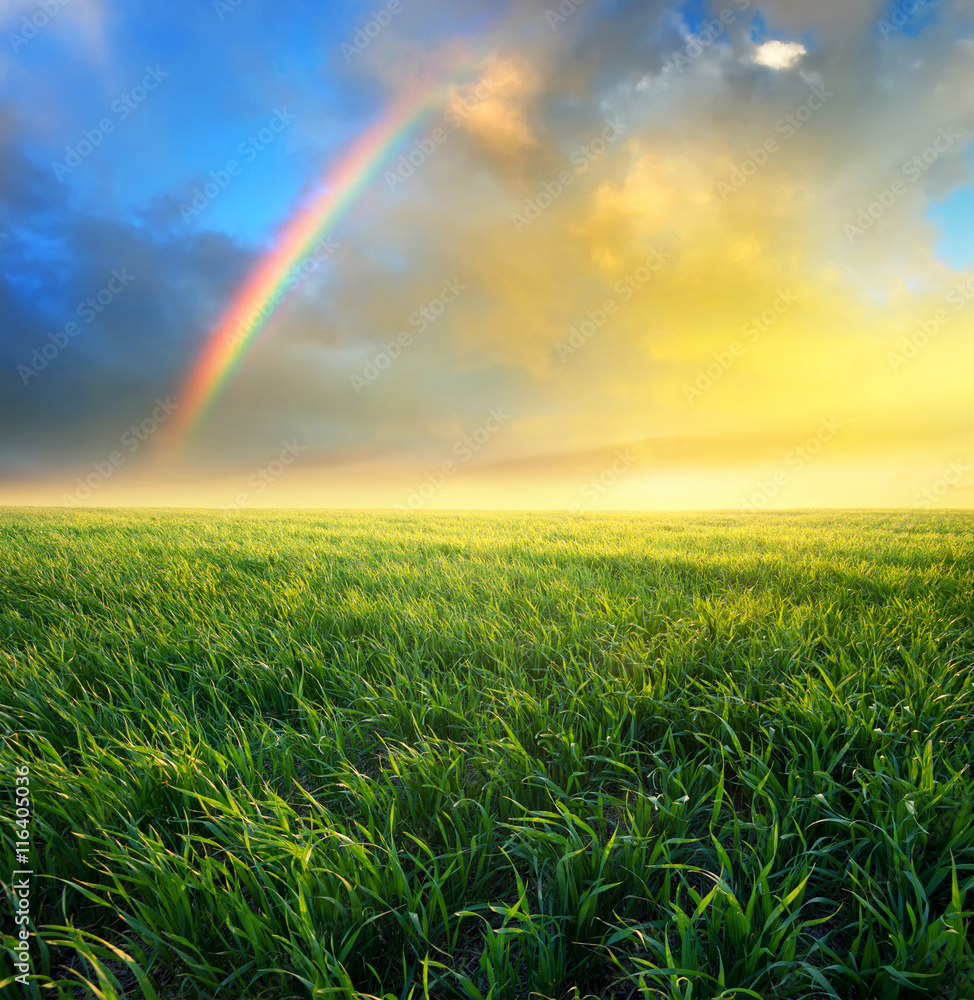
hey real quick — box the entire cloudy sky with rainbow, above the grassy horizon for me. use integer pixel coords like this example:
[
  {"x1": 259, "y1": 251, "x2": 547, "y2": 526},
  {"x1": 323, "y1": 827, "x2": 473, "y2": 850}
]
[{"x1": 0, "y1": 0, "x2": 974, "y2": 513}]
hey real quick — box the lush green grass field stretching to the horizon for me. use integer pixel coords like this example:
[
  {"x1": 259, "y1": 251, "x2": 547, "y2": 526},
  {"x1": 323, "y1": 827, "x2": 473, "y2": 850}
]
[{"x1": 0, "y1": 510, "x2": 974, "y2": 1000}]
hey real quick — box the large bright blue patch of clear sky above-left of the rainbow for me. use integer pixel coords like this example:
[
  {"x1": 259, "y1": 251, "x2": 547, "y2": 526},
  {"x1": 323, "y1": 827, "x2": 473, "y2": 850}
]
[{"x1": 10, "y1": 0, "x2": 382, "y2": 239}]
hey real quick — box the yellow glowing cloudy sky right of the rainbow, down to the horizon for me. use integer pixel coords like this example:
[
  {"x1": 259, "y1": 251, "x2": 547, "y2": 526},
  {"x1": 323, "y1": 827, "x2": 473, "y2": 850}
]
[{"x1": 5, "y1": 2, "x2": 974, "y2": 510}]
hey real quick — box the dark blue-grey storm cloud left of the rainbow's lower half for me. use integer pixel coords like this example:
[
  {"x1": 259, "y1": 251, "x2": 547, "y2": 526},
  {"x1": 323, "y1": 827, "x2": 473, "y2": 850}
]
[{"x1": 0, "y1": 109, "x2": 251, "y2": 469}]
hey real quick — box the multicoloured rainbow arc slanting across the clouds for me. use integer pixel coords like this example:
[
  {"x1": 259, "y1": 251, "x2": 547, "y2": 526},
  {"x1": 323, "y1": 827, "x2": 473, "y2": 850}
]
[{"x1": 164, "y1": 80, "x2": 456, "y2": 455}]
